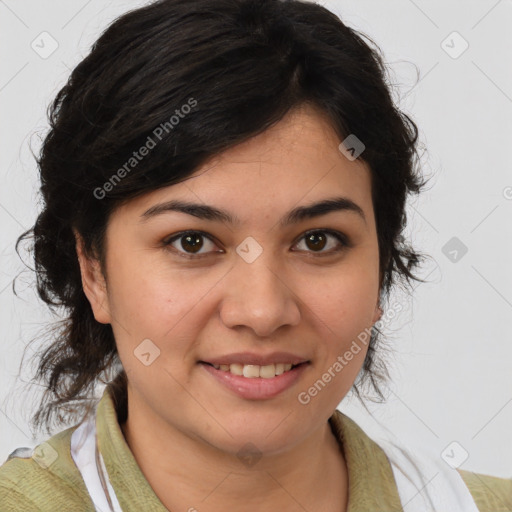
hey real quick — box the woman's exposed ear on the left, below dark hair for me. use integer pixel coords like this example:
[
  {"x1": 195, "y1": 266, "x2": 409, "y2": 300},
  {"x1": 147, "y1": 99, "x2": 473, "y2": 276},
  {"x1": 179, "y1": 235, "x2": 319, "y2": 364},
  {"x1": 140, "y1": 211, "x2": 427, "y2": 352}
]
[{"x1": 73, "y1": 229, "x2": 111, "y2": 324}]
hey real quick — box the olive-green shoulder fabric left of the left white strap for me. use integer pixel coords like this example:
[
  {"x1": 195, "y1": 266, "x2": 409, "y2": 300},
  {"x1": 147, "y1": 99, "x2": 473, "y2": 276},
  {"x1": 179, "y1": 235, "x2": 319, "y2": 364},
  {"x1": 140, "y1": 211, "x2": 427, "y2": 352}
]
[{"x1": 0, "y1": 426, "x2": 94, "y2": 512}]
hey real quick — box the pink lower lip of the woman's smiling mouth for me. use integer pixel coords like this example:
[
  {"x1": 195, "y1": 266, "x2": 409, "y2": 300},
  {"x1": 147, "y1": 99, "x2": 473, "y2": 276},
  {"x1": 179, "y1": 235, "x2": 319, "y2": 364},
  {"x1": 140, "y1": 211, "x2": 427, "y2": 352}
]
[{"x1": 199, "y1": 363, "x2": 309, "y2": 400}]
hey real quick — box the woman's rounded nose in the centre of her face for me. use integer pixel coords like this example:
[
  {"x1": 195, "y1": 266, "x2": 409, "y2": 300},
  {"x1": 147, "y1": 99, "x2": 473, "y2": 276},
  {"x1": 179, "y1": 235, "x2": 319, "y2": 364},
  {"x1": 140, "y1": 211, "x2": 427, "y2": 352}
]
[{"x1": 220, "y1": 247, "x2": 300, "y2": 337}]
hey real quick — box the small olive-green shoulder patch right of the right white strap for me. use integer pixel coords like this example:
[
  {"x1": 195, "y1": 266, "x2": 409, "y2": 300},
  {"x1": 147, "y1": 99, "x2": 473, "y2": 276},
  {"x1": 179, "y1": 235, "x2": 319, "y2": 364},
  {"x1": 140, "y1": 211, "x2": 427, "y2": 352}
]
[{"x1": 457, "y1": 469, "x2": 512, "y2": 512}]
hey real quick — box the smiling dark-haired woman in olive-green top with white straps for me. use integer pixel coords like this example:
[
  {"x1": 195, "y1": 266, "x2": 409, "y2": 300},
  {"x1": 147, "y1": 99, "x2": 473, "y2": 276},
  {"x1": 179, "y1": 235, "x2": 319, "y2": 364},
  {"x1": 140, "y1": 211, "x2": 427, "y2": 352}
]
[{"x1": 0, "y1": 0, "x2": 512, "y2": 512}]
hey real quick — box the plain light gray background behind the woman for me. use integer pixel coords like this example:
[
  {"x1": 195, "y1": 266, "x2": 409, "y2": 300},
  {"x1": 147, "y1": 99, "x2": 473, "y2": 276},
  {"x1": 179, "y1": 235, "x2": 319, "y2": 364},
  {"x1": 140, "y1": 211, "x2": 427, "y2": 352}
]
[{"x1": 0, "y1": 0, "x2": 512, "y2": 478}]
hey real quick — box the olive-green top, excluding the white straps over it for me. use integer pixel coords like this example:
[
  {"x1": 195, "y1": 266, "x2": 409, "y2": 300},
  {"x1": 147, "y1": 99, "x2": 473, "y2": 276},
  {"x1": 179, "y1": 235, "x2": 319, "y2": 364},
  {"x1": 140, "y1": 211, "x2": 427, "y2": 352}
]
[{"x1": 0, "y1": 386, "x2": 512, "y2": 512}]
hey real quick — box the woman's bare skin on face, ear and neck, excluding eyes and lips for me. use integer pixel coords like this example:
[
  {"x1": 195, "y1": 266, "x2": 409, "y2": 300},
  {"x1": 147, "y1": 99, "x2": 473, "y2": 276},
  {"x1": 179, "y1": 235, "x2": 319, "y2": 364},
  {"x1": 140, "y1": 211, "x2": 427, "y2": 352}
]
[{"x1": 77, "y1": 106, "x2": 382, "y2": 512}]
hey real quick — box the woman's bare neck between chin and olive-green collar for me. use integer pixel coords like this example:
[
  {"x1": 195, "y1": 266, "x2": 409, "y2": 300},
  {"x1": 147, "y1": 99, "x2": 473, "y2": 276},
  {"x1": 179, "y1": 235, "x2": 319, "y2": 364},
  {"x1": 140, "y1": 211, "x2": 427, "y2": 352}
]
[{"x1": 121, "y1": 386, "x2": 348, "y2": 512}]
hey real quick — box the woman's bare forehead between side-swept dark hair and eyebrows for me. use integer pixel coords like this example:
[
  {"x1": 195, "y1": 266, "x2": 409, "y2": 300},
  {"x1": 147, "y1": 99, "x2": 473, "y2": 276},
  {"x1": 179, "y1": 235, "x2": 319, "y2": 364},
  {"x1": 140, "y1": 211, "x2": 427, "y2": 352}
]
[{"x1": 115, "y1": 106, "x2": 372, "y2": 221}]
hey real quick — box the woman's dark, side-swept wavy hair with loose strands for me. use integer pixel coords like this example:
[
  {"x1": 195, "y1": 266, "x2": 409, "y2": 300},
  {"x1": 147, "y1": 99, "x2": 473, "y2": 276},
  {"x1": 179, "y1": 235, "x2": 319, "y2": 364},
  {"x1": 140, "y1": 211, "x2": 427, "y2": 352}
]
[{"x1": 16, "y1": 0, "x2": 432, "y2": 432}]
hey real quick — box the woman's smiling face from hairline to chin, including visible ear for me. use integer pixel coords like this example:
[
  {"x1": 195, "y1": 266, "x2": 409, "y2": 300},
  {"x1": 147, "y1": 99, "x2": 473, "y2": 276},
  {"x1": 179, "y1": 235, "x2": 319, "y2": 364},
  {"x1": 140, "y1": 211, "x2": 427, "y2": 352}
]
[{"x1": 75, "y1": 107, "x2": 380, "y2": 454}]
